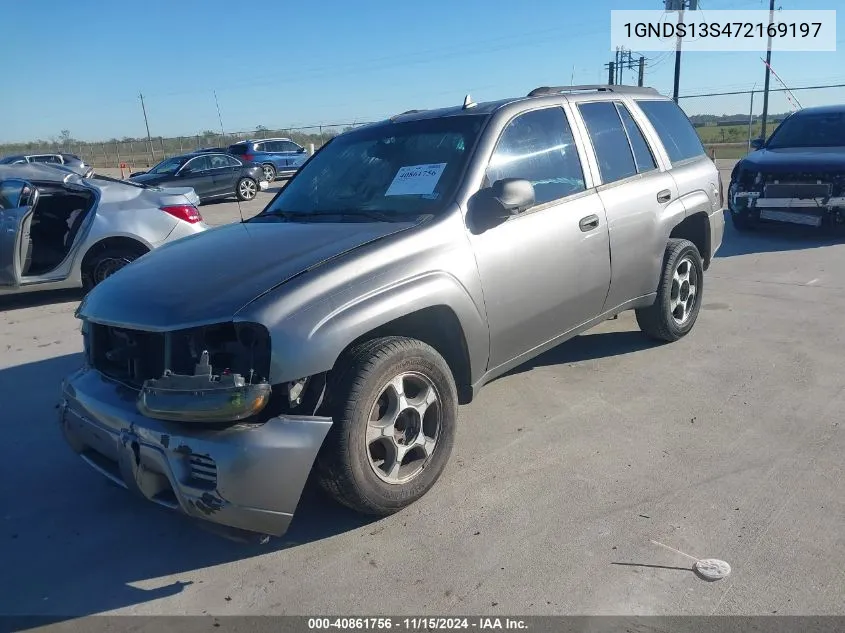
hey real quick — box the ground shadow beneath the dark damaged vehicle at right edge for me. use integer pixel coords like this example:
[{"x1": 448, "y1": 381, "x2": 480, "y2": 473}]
[{"x1": 716, "y1": 212, "x2": 845, "y2": 259}]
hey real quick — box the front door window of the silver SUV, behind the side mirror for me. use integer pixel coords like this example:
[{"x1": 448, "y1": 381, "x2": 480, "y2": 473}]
[{"x1": 487, "y1": 107, "x2": 585, "y2": 204}]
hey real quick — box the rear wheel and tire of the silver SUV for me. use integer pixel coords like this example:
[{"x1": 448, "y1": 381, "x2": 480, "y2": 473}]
[{"x1": 636, "y1": 239, "x2": 704, "y2": 342}]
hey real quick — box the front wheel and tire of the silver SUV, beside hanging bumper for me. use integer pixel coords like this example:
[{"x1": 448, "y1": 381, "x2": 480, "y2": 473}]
[{"x1": 315, "y1": 336, "x2": 458, "y2": 516}]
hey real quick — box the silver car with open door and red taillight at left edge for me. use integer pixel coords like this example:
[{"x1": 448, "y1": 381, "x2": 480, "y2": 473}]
[{"x1": 0, "y1": 163, "x2": 208, "y2": 296}]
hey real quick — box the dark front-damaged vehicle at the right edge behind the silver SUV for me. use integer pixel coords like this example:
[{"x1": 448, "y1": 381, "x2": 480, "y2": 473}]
[{"x1": 728, "y1": 105, "x2": 845, "y2": 230}]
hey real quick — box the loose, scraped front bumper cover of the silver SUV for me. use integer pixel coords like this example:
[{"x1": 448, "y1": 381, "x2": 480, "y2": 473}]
[{"x1": 59, "y1": 367, "x2": 331, "y2": 536}]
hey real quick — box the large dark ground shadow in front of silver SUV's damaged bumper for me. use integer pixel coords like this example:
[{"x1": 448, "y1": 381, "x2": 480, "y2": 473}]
[{"x1": 0, "y1": 354, "x2": 372, "y2": 620}]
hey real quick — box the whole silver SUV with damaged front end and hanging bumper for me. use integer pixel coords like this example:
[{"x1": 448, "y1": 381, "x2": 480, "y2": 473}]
[{"x1": 60, "y1": 86, "x2": 724, "y2": 539}]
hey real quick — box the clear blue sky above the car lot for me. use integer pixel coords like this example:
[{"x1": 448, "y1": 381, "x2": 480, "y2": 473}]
[{"x1": 0, "y1": 0, "x2": 845, "y2": 141}]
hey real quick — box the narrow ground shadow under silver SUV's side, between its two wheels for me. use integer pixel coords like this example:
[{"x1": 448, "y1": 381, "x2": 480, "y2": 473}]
[{"x1": 502, "y1": 330, "x2": 663, "y2": 378}]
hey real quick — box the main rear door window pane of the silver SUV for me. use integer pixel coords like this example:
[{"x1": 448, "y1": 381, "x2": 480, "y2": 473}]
[{"x1": 578, "y1": 101, "x2": 637, "y2": 184}]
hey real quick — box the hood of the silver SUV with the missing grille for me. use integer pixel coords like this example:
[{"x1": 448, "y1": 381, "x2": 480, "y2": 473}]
[{"x1": 77, "y1": 222, "x2": 414, "y2": 331}]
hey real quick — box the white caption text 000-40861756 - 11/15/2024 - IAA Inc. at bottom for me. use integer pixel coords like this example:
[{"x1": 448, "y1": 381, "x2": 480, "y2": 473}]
[{"x1": 308, "y1": 616, "x2": 528, "y2": 631}]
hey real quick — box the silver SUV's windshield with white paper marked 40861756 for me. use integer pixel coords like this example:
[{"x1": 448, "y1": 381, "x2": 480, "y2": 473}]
[{"x1": 257, "y1": 115, "x2": 486, "y2": 221}]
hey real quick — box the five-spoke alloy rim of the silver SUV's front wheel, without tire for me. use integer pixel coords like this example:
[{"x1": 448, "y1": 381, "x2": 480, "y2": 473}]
[{"x1": 366, "y1": 372, "x2": 442, "y2": 484}]
